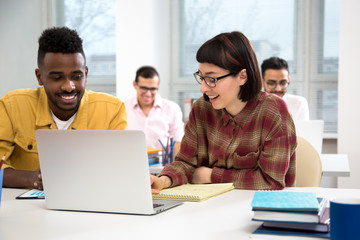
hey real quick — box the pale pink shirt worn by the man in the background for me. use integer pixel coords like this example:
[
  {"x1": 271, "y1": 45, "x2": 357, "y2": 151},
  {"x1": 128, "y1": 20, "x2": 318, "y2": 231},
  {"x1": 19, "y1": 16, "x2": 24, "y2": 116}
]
[{"x1": 125, "y1": 94, "x2": 184, "y2": 149}]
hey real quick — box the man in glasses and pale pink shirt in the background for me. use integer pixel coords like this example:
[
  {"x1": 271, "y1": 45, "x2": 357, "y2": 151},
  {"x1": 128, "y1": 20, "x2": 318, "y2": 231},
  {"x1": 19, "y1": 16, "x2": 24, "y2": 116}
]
[{"x1": 125, "y1": 66, "x2": 184, "y2": 149}]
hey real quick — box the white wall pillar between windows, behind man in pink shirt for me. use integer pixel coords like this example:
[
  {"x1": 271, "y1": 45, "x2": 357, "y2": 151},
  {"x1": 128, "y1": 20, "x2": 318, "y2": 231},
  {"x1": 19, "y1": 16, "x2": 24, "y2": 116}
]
[{"x1": 116, "y1": 0, "x2": 171, "y2": 100}]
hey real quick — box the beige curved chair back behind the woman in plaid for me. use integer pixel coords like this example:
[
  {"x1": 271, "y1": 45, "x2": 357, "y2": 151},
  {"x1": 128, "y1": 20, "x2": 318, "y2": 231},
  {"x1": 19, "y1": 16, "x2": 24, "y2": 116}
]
[{"x1": 295, "y1": 136, "x2": 322, "y2": 187}]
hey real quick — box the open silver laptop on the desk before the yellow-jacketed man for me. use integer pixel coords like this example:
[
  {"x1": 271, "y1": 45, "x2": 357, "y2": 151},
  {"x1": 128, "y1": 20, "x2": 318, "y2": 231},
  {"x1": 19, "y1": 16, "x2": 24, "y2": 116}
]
[{"x1": 36, "y1": 130, "x2": 181, "y2": 215}]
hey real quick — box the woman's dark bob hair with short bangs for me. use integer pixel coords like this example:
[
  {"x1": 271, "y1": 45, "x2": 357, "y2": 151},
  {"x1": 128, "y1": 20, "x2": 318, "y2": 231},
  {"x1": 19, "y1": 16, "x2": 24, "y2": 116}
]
[{"x1": 196, "y1": 32, "x2": 262, "y2": 102}]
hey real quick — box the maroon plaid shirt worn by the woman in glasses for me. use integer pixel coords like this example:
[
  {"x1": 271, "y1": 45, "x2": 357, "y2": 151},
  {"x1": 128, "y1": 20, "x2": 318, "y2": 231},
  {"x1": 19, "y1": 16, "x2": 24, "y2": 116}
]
[{"x1": 162, "y1": 93, "x2": 296, "y2": 189}]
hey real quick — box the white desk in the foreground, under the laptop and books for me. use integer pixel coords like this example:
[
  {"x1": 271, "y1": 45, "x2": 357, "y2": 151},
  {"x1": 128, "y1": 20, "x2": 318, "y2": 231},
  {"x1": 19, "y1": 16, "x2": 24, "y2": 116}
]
[{"x1": 0, "y1": 188, "x2": 360, "y2": 240}]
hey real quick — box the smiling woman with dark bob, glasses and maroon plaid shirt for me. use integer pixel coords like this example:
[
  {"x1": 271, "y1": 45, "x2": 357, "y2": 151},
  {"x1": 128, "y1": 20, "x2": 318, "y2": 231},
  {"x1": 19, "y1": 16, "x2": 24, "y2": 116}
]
[{"x1": 151, "y1": 32, "x2": 296, "y2": 193}]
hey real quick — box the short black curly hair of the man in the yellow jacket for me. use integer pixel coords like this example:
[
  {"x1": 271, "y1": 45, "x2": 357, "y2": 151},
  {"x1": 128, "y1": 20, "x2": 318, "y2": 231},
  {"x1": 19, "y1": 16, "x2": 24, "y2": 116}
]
[{"x1": 37, "y1": 27, "x2": 85, "y2": 66}]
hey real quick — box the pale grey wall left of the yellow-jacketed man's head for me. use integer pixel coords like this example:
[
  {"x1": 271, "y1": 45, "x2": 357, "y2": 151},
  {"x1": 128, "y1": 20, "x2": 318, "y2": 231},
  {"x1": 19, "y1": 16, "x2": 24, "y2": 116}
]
[{"x1": 0, "y1": 0, "x2": 47, "y2": 97}]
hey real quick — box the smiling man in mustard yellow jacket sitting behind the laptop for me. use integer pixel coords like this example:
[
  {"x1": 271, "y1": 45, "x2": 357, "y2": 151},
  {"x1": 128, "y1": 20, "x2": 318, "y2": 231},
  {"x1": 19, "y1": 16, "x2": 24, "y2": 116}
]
[{"x1": 0, "y1": 27, "x2": 127, "y2": 189}]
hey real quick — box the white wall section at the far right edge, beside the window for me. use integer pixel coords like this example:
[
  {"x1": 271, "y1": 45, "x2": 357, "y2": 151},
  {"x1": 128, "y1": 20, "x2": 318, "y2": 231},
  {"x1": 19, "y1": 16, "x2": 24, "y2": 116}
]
[{"x1": 338, "y1": 0, "x2": 360, "y2": 188}]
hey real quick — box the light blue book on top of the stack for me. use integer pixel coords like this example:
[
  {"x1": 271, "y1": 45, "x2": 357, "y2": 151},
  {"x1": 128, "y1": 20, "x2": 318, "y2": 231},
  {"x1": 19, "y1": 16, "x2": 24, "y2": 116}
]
[{"x1": 251, "y1": 191, "x2": 320, "y2": 212}]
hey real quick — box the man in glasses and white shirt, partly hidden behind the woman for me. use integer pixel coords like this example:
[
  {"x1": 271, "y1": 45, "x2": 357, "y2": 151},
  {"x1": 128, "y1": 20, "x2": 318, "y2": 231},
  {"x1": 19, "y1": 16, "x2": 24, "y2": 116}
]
[{"x1": 261, "y1": 57, "x2": 309, "y2": 120}]
